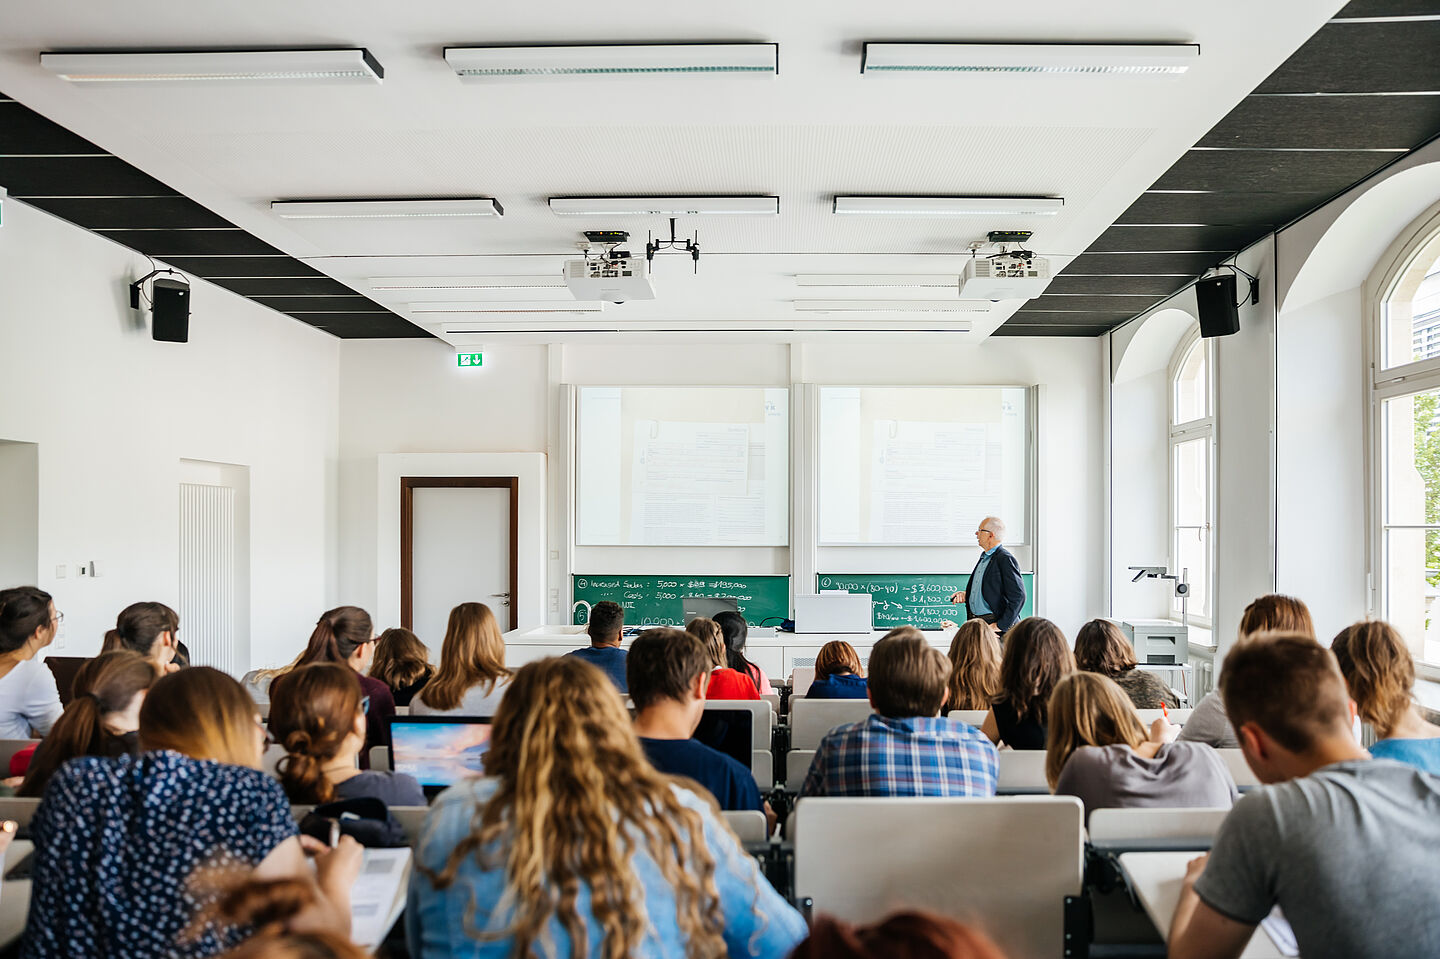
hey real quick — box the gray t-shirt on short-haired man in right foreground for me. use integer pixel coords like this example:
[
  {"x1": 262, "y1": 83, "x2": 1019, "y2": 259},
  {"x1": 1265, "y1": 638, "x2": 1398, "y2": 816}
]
[{"x1": 1195, "y1": 759, "x2": 1440, "y2": 959}]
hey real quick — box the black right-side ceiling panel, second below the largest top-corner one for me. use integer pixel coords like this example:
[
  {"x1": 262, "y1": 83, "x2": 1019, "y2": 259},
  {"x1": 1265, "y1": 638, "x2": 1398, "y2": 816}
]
[{"x1": 1151, "y1": 150, "x2": 1403, "y2": 194}]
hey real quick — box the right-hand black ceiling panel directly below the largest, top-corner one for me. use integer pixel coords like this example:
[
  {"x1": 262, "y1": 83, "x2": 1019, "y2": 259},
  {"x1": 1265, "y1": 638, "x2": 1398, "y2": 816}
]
[{"x1": 1195, "y1": 96, "x2": 1440, "y2": 150}]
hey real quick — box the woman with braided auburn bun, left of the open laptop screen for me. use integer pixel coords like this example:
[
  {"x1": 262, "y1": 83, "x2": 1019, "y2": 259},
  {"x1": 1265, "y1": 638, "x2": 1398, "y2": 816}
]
[{"x1": 269, "y1": 662, "x2": 425, "y2": 806}]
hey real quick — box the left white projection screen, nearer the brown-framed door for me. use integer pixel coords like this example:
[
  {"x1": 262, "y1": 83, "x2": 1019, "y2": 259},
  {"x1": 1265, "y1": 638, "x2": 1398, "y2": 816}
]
[{"x1": 575, "y1": 386, "x2": 791, "y2": 546}]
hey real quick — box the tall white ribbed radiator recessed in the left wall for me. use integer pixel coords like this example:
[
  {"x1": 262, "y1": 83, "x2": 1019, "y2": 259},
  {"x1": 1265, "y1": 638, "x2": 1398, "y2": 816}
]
[{"x1": 179, "y1": 482, "x2": 238, "y2": 674}]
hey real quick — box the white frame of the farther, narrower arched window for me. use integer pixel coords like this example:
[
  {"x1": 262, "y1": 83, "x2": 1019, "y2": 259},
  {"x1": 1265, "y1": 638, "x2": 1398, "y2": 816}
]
[{"x1": 1165, "y1": 323, "x2": 1217, "y2": 629}]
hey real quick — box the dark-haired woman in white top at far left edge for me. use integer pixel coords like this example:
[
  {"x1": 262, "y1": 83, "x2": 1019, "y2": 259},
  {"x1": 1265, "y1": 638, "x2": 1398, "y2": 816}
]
[{"x1": 0, "y1": 586, "x2": 63, "y2": 739}]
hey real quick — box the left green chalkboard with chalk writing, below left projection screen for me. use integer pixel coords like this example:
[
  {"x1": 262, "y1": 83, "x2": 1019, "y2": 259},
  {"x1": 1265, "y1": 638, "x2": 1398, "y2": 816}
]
[{"x1": 572, "y1": 576, "x2": 791, "y2": 626}]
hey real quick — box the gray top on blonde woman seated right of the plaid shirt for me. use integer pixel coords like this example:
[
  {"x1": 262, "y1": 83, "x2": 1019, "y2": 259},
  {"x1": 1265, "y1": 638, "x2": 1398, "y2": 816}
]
[{"x1": 1056, "y1": 743, "x2": 1238, "y2": 822}]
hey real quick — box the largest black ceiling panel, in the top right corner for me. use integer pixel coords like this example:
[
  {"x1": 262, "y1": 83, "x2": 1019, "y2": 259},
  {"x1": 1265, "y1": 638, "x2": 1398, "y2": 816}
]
[{"x1": 1256, "y1": 20, "x2": 1440, "y2": 94}]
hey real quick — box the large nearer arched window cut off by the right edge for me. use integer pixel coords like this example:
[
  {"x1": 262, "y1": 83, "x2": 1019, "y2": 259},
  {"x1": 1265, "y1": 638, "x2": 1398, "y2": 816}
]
[{"x1": 1367, "y1": 208, "x2": 1440, "y2": 664}]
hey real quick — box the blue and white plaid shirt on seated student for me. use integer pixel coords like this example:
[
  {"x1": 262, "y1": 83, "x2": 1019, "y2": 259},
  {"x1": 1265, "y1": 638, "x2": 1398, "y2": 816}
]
[{"x1": 801, "y1": 713, "x2": 999, "y2": 796}]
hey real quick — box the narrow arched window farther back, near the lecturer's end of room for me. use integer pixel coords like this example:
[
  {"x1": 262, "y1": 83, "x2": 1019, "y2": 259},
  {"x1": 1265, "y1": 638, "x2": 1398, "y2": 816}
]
[{"x1": 1169, "y1": 327, "x2": 1215, "y2": 626}]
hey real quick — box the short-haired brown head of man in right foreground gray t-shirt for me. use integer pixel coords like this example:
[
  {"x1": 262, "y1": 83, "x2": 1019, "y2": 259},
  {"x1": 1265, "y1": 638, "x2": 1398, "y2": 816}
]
[{"x1": 1220, "y1": 632, "x2": 1354, "y2": 755}]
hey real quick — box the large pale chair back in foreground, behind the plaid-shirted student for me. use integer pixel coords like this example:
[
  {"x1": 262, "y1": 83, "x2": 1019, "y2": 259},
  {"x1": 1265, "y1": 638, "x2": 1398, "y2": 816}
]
[{"x1": 793, "y1": 796, "x2": 1084, "y2": 956}]
